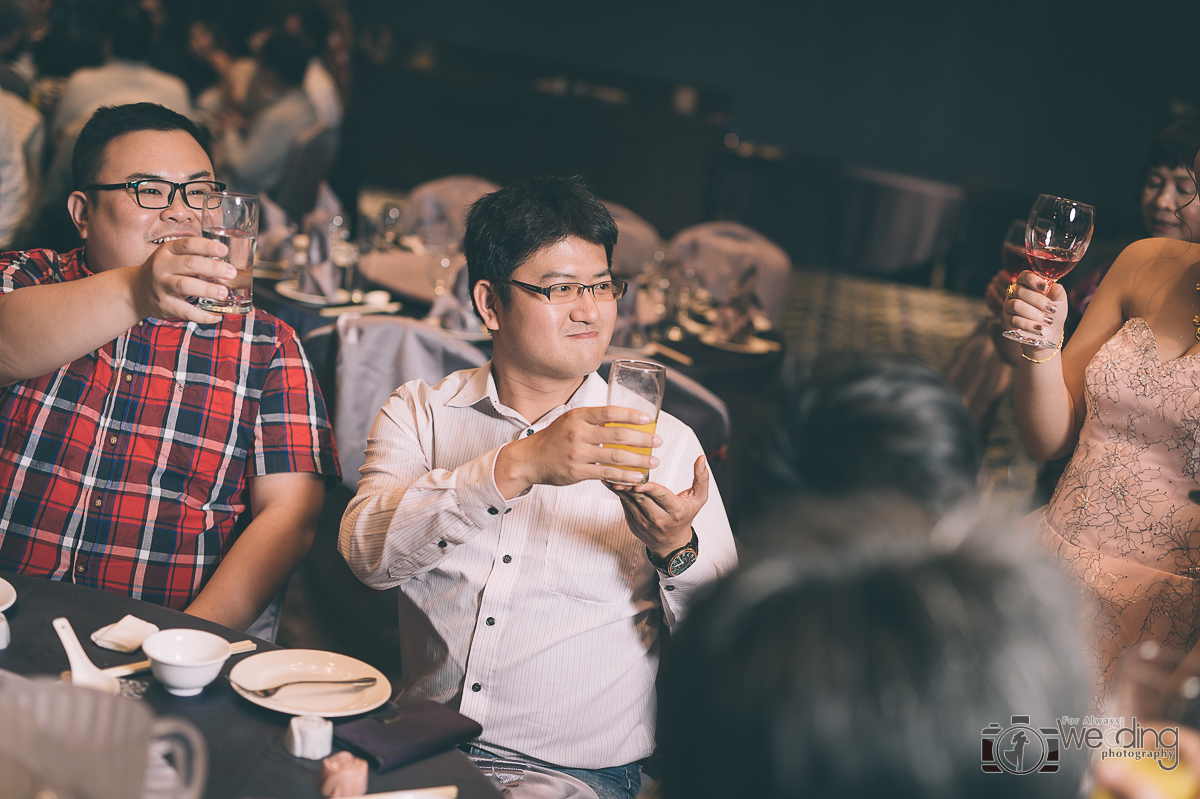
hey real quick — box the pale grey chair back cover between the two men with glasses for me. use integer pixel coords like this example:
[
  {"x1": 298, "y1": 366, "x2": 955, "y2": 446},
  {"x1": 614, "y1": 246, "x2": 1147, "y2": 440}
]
[{"x1": 333, "y1": 314, "x2": 487, "y2": 488}]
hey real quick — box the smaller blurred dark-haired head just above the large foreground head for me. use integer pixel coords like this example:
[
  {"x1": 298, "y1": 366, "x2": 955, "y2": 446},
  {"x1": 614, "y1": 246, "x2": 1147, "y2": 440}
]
[{"x1": 756, "y1": 356, "x2": 983, "y2": 518}]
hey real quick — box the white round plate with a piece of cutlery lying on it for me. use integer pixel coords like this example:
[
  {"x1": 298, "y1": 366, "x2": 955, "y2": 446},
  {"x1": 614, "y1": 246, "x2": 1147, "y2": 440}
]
[{"x1": 229, "y1": 649, "x2": 391, "y2": 719}]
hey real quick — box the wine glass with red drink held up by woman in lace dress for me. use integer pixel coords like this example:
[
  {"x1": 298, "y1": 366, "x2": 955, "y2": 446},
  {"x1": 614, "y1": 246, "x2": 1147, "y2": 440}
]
[{"x1": 1004, "y1": 194, "x2": 1096, "y2": 349}]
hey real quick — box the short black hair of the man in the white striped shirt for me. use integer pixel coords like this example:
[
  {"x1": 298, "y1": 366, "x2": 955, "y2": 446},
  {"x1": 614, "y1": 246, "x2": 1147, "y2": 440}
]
[{"x1": 462, "y1": 176, "x2": 617, "y2": 313}]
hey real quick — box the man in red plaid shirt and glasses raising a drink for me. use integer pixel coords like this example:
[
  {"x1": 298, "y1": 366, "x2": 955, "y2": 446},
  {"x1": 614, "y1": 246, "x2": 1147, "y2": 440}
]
[{"x1": 0, "y1": 103, "x2": 338, "y2": 629}]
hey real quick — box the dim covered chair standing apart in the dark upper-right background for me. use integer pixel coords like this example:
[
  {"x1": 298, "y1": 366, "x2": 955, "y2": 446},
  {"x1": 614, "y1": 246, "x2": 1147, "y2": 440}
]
[{"x1": 834, "y1": 168, "x2": 966, "y2": 280}]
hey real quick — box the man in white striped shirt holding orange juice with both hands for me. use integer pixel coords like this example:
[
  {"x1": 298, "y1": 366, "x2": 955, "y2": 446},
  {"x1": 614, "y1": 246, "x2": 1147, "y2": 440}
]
[{"x1": 340, "y1": 178, "x2": 737, "y2": 799}]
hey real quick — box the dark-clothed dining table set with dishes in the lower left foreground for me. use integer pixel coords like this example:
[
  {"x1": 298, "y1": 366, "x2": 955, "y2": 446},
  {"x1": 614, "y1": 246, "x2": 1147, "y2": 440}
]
[{"x1": 0, "y1": 572, "x2": 500, "y2": 799}]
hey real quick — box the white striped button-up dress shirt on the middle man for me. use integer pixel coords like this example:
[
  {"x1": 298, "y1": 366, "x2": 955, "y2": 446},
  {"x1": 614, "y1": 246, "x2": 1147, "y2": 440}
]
[{"x1": 338, "y1": 364, "x2": 737, "y2": 768}]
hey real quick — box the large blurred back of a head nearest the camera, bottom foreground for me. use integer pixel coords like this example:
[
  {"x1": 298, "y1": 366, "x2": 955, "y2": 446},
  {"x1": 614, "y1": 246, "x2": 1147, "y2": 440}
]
[{"x1": 658, "y1": 507, "x2": 1088, "y2": 799}]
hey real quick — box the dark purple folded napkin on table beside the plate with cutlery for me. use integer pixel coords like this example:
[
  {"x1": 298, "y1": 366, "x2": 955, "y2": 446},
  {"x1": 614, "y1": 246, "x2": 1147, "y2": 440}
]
[{"x1": 334, "y1": 699, "x2": 484, "y2": 771}]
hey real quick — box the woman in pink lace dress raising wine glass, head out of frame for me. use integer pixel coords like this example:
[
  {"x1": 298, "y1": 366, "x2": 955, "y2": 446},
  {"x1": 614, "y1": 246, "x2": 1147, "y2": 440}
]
[{"x1": 1004, "y1": 172, "x2": 1200, "y2": 689}]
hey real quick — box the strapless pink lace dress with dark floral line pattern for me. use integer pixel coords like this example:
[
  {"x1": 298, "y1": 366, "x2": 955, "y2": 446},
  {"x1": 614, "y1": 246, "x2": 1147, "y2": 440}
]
[{"x1": 1038, "y1": 318, "x2": 1200, "y2": 690}]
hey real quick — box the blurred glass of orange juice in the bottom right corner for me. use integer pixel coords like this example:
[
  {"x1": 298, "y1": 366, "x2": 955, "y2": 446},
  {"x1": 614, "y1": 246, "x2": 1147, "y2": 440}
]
[{"x1": 1092, "y1": 641, "x2": 1200, "y2": 799}]
